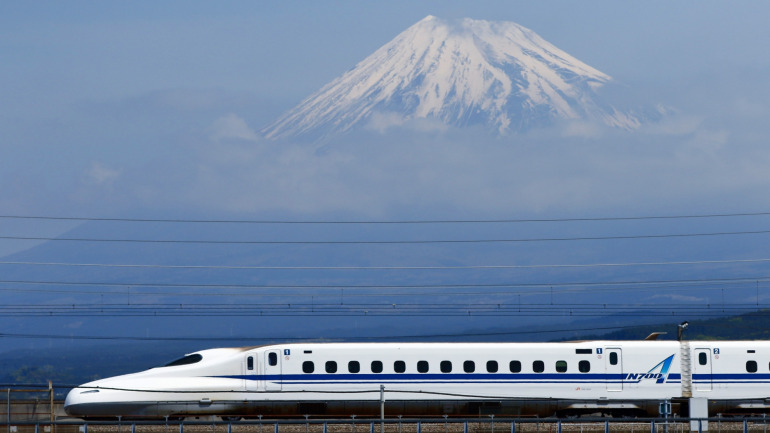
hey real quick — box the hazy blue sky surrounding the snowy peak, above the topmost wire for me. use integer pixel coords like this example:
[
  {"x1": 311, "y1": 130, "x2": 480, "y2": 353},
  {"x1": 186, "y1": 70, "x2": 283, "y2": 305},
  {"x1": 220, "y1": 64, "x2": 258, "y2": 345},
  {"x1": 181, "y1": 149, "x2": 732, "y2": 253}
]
[{"x1": 0, "y1": 0, "x2": 770, "y2": 224}]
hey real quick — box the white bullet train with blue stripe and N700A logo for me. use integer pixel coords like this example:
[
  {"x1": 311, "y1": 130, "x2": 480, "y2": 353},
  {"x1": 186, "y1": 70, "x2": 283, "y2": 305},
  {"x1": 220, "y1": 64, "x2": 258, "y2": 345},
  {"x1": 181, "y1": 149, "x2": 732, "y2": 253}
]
[{"x1": 64, "y1": 340, "x2": 770, "y2": 420}]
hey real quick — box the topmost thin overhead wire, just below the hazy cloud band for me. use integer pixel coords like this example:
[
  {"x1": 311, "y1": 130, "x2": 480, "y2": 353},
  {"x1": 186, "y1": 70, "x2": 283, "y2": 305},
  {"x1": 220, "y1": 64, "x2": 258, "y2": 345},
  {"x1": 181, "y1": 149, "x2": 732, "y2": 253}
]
[{"x1": 0, "y1": 212, "x2": 770, "y2": 224}]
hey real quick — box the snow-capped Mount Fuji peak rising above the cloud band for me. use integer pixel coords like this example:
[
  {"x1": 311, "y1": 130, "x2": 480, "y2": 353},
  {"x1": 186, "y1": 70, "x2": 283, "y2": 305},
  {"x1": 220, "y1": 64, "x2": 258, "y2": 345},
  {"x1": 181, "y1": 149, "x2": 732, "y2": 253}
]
[{"x1": 261, "y1": 16, "x2": 644, "y2": 140}]
